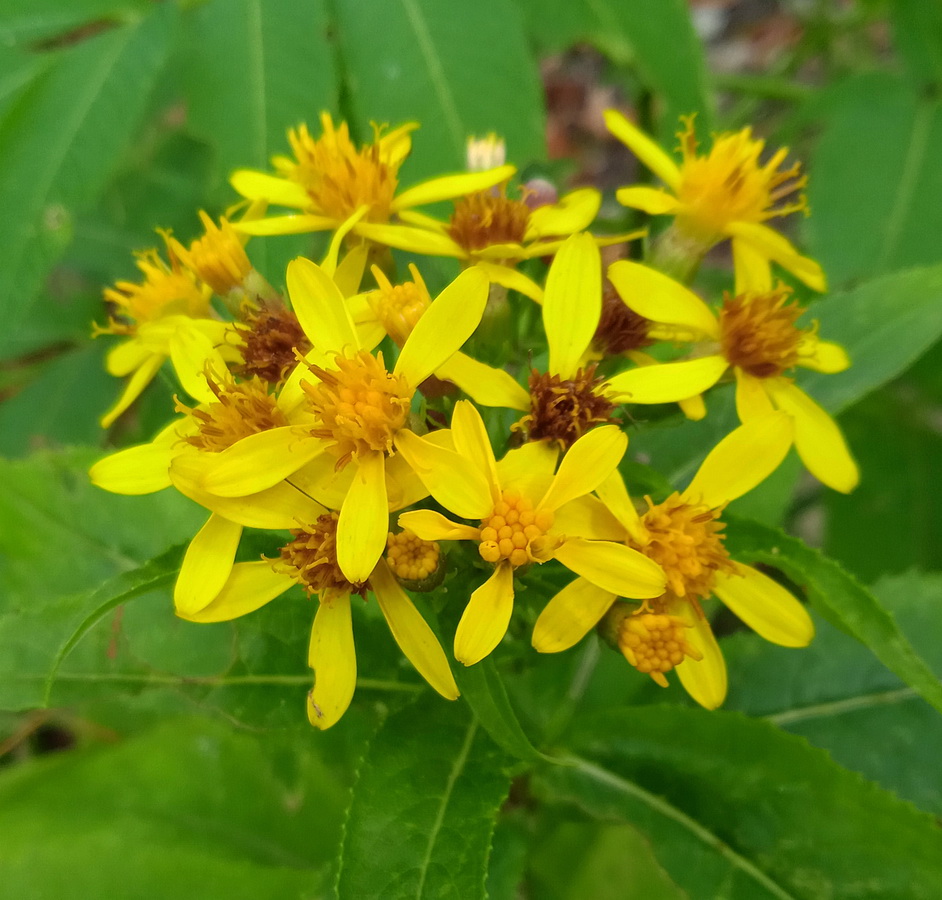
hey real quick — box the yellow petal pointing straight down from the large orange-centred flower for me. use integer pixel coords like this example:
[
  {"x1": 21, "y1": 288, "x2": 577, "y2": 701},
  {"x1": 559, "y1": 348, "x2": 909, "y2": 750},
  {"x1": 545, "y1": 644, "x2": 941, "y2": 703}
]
[{"x1": 337, "y1": 451, "x2": 389, "y2": 584}]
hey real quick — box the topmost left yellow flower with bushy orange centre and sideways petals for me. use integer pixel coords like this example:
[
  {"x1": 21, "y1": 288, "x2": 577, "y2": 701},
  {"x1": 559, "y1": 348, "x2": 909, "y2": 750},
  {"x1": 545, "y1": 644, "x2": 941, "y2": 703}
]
[{"x1": 232, "y1": 112, "x2": 515, "y2": 253}]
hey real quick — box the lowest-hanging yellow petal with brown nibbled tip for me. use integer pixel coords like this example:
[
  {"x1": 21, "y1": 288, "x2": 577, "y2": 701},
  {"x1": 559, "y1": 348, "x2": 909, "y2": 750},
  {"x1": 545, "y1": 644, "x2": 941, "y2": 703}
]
[{"x1": 307, "y1": 594, "x2": 357, "y2": 731}]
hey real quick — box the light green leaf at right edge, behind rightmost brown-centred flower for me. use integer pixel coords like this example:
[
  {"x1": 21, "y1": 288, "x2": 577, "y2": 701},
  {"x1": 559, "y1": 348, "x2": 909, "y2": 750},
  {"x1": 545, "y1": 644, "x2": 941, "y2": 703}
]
[{"x1": 796, "y1": 260, "x2": 942, "y2": 413}]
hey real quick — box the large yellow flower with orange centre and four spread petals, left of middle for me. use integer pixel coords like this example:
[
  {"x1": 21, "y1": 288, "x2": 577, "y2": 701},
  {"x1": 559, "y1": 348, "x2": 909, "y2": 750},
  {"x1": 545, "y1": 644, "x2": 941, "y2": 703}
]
[{"x1": 188, "y1": 258, "x2": 488, "y2": 583}]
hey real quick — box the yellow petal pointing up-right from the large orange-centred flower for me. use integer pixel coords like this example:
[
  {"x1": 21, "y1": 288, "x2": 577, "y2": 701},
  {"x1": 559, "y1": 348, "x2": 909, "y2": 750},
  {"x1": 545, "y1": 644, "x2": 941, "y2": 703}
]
[{"x1": 395, "y1": 267, "x2": 489, "y2": 387}]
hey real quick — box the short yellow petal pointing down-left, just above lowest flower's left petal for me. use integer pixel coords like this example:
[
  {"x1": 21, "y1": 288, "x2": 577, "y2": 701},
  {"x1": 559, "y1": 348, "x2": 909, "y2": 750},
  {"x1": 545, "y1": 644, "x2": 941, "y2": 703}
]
[{"x1": 173, "y1": 513, "x2": 242, "y2": 616}]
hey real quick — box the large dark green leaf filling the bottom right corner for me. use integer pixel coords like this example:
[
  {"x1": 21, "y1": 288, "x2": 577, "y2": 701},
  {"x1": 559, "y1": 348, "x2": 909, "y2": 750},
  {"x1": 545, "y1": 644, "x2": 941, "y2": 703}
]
[{"x1": 540, "y1": 707, "x2": 942, "y2": 900}]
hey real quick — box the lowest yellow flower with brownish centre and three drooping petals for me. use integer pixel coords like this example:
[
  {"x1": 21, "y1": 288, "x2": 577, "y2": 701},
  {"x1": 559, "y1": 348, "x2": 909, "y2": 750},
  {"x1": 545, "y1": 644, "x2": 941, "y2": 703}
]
[{"x1": 178, "y1": 512, "x2": 458, "y2": 729}]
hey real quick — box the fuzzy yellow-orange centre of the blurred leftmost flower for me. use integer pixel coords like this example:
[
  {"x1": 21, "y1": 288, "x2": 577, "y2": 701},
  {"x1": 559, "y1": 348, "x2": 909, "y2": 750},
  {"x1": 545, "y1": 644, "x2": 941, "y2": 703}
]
[{"x1": 99, "y1": 248, "x2": 212, "y2": 334}]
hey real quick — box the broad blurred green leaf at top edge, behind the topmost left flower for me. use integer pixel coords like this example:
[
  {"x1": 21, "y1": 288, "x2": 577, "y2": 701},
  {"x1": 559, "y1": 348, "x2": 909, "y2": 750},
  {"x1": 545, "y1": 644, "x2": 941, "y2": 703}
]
[{"x1": 335, "y1": 0, "x2": 546, "y2": 178}]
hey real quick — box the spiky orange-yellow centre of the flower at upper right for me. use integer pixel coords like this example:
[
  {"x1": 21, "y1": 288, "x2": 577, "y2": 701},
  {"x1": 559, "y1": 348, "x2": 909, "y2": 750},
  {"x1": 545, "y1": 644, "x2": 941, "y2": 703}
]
[{"x1": 677, "y1": 116, "x2": 808, "y2": 243}]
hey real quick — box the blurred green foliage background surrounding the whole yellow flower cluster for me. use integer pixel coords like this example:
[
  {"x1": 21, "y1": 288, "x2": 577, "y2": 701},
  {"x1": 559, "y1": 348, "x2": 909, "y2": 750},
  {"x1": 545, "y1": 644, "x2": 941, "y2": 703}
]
[{"x1": 0, "y1": 0, "x2": 942, "y2": 900}]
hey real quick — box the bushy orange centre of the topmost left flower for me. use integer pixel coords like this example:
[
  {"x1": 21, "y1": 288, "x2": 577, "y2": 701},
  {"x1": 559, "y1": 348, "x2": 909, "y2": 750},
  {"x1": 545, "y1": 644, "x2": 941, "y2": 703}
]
[{"x1": 275, "y1": 113, "x2": 399, "y2": 222}]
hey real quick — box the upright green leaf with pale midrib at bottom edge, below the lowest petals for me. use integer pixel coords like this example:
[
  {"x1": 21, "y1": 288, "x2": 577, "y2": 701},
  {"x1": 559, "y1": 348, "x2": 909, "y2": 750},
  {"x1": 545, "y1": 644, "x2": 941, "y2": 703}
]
[{"x1": 337, "y1": 697, "x2": 509, "y2": 900}]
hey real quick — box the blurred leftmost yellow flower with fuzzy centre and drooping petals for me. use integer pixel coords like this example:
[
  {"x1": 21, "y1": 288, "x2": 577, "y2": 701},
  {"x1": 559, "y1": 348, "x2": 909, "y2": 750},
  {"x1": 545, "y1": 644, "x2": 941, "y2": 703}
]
[{"x1": 95, "y1": 245, "x2": 232, "y2": 428}]
